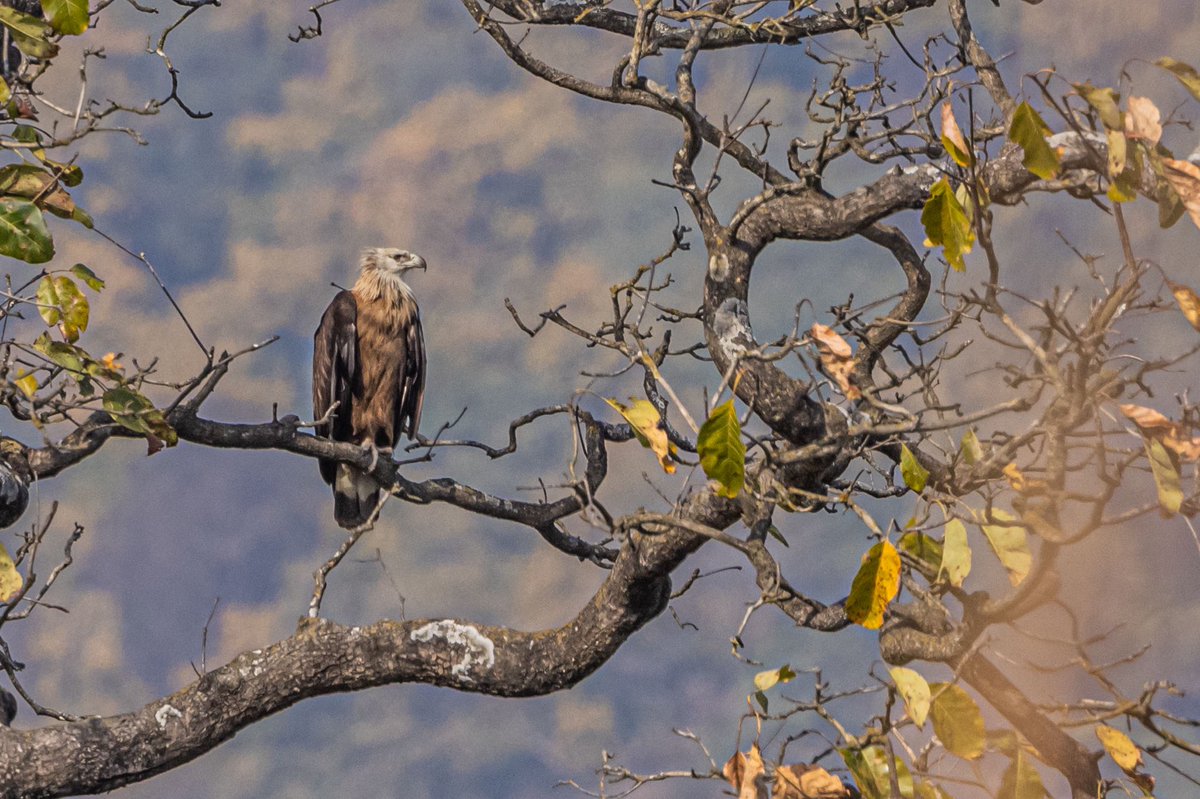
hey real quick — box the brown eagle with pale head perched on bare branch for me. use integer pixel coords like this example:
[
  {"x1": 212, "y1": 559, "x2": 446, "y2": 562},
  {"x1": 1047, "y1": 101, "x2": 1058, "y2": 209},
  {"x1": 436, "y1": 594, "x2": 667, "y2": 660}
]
[{"x1": 312, "y1": 247, "x2": 425, "y2": 529}]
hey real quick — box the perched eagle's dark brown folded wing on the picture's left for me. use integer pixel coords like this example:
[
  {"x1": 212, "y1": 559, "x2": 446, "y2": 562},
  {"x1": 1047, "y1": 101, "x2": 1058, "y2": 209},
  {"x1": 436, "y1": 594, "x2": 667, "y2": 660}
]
[{"x1": 312, "y1": 292, "x2": 359, "y2": 485}]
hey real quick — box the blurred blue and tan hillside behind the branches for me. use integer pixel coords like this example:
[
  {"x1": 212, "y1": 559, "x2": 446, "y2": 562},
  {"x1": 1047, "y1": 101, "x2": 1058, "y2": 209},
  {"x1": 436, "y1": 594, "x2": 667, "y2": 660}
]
[{"x1": 4, "y1": 0, "x2": 1200, "y2": 799}]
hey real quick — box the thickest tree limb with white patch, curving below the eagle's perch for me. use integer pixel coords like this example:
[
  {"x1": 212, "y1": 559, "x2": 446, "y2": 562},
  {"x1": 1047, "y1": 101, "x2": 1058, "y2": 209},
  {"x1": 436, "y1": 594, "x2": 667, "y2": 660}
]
[{"x1": 0, "y1": 484, "x2": 738, "y2": 799}]
